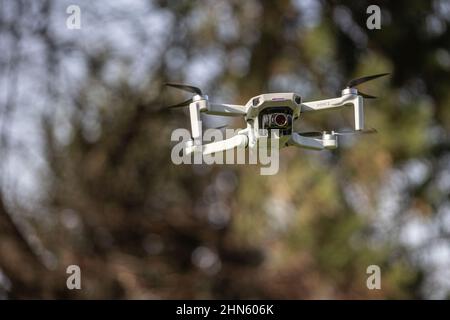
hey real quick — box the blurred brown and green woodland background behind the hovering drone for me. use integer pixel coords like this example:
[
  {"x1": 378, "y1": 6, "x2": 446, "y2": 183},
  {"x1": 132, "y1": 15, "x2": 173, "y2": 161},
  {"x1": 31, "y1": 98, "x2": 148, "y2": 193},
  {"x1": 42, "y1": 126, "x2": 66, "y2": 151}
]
[{"x1": 0, "y1": 0, "x2": 450, "y2": 299}]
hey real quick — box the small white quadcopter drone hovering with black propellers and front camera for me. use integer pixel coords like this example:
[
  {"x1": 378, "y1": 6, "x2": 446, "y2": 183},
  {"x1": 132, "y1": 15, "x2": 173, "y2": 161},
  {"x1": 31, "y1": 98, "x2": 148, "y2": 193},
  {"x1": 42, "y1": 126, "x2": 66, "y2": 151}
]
[{"x1": 166, "y1": 73, "x2": 389, "y2": 155}]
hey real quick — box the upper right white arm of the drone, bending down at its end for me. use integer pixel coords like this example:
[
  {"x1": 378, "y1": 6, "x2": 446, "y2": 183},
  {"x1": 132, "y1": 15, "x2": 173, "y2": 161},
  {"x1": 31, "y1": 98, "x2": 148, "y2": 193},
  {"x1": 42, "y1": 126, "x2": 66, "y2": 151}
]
[{"x1": 301, "y1": 94, "x2": 364, "y2": 130}]
